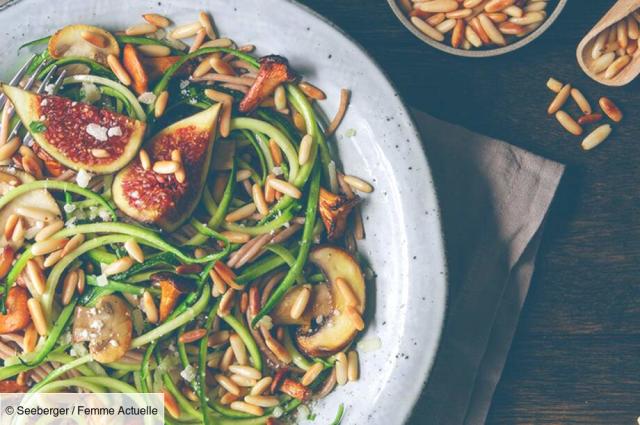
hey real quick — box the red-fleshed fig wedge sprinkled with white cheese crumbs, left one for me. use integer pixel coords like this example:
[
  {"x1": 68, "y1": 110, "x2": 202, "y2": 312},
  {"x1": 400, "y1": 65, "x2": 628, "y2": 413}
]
[{"x1": 2, "y1": 85, "x2": 146, "y2": 174}]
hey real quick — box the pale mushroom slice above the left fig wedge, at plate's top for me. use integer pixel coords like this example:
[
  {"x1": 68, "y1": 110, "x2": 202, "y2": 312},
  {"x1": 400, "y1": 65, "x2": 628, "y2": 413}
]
[{"x1": 49, "y1": 25, "x2": 120, "y2": 65}]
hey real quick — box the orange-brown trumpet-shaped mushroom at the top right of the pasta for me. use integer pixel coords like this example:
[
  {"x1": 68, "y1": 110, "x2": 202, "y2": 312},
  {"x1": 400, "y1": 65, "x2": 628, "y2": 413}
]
[{"x1": 239, "y1": 55, "x2": 296, "y2": 113}]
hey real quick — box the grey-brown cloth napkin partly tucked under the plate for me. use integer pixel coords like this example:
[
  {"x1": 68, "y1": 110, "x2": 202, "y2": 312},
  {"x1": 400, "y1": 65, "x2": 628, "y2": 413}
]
[{"x1": 409, "y1": 112, "x2": 564, "y2": 425}]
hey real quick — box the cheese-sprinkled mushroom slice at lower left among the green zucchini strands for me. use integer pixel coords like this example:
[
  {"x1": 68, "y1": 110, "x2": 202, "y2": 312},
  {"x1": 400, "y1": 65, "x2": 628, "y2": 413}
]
[{"x1": 73, "y1": 295, "x2": 133, "y2": 363}]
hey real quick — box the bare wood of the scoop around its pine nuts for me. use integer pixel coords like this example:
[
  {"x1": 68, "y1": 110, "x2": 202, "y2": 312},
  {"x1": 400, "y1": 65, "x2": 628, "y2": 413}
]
[{"x1": 576, "y1": 0, "x2": 640, "y2": 86}]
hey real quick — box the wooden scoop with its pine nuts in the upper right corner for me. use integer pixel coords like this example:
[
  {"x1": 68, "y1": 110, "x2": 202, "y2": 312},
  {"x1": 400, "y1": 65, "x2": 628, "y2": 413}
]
[{"x1": 576, "y1": 0, "x2": 640, "y2": 86}]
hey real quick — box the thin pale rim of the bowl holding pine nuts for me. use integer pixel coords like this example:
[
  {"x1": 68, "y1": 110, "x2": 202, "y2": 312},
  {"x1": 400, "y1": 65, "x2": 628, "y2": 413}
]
[{"x1": 387, "y1": 0, "x2": 567, "y2": 58}]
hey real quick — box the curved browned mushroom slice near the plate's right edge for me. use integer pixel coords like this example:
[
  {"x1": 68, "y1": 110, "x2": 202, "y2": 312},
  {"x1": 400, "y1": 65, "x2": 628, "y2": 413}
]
[{"x1": 296, "y1": 246, "x2": 365, "y2": 357}]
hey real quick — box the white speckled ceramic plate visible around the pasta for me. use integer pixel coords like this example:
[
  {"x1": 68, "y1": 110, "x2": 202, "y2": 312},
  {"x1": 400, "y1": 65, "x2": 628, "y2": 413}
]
[{"x1": 0, "y1": 0, "x2": 446, "y2": 425}]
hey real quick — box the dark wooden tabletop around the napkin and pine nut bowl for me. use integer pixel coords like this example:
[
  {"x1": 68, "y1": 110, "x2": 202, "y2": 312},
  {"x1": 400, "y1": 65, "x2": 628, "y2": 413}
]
[{"x1": 304, "y1": 0, "x2": 640, "y2": 425}]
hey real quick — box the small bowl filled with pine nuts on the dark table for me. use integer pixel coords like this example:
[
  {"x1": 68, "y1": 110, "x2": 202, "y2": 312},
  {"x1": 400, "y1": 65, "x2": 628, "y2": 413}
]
[{"x1": 387, "y1": 0, "x2": 567, "y2": 57}]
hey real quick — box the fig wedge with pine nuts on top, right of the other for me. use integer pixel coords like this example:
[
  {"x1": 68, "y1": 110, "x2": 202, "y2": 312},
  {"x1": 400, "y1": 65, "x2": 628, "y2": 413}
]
[{"x1": 113, "y1": 104, "x2": 220, "y2": 231}]
